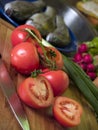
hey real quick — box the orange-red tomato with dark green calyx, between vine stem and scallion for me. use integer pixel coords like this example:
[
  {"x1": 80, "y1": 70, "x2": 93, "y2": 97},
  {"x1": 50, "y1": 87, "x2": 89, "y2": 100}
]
[{"x1": 38, "y1": 47, "x2": 64, "y2": 69}]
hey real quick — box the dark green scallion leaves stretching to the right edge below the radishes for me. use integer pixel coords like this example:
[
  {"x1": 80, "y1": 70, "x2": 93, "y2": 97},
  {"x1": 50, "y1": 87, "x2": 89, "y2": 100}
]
[{"x1": 63, "y1": 55, "x2": 98, "y2": 115}]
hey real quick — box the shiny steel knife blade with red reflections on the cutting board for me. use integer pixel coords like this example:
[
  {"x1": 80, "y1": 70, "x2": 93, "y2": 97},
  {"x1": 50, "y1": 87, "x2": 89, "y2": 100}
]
[{"x1": 0, "y1": 58, "x2": 30, "y2": 130}]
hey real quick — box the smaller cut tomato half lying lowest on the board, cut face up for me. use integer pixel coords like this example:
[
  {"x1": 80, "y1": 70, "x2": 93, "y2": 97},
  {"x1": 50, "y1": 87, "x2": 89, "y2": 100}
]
[{"x1": 53, "y1": 96, "x2": 83, "y2": 127}]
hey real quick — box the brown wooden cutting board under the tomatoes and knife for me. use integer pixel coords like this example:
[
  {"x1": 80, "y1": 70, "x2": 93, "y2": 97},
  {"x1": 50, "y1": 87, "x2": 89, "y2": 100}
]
[{"x1": 0, "y1": 19, "x2": 98, "y2": 130}]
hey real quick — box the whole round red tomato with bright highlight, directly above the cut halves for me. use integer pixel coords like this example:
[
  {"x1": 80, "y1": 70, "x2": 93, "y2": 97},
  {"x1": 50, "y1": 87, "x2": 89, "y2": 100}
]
[{"x1": 11, "y1": 42, "x2": 39, "y2": 75}]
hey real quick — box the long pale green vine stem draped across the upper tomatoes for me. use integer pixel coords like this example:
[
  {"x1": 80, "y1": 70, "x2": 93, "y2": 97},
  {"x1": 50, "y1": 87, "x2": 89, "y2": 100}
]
[{"x1": 25, "y1": 28, "x2": 55, "y2": 69}]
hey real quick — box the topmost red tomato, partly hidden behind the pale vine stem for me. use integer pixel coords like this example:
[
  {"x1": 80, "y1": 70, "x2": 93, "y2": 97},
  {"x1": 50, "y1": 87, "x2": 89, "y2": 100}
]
[{"x1": 11, "y1": 24, "x2": 41, "y2": 46}]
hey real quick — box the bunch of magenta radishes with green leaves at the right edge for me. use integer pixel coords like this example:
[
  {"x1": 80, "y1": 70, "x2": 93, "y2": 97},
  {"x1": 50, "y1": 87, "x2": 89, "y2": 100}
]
[{"x1": 73, "y1": 37, "x2": 98, "y2": 80}]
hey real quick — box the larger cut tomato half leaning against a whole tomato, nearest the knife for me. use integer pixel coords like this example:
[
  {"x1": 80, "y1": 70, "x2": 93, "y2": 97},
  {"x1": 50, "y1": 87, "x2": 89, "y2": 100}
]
[{"x1": 17, "y1": 76, "x2": 53, "y2": 108}]
